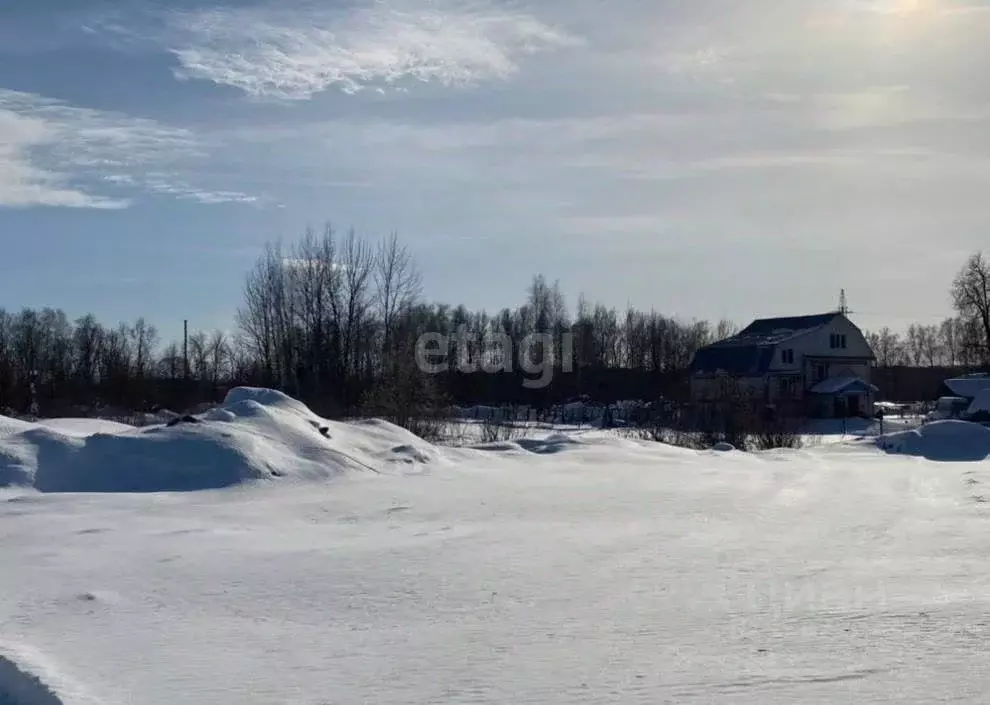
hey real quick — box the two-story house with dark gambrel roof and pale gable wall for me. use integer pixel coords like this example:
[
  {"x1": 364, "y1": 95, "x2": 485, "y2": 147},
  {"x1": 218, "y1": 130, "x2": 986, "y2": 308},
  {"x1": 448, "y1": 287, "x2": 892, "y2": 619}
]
[{"x1": 691, "y1": 312, "x2": 877, "y2": 418}]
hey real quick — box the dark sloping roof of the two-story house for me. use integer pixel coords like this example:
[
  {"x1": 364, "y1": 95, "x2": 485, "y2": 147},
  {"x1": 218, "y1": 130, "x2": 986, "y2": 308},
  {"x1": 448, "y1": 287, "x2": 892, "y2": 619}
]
[{"x1": 691, "y1": 312, "x2": 842, "y2": 375}]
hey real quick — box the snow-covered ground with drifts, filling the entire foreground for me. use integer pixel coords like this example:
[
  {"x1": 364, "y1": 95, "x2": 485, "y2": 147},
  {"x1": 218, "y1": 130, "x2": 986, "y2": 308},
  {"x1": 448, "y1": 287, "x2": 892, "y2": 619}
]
[{"x1": 0, "y1": 390, "x2": 990, "y2": 705}]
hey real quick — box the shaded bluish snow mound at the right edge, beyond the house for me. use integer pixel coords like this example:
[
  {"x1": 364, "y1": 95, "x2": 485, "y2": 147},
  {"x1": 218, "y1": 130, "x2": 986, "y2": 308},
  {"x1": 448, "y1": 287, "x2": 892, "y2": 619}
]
[{"x1": 877, "y1": 420, "x2": 990, "y2": 462}]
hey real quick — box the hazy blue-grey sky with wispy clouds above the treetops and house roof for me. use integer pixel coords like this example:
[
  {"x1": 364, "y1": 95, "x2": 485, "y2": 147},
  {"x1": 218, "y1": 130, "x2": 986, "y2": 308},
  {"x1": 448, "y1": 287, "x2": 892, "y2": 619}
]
[{"x1": 0, "y1": 0, "x2": 990, "y2": 334}]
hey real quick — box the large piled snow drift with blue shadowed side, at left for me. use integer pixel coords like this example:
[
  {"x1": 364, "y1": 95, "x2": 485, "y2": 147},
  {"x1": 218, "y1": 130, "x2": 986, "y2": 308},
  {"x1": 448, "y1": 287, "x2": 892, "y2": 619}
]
[{"x1": 0, "y1": 387, "x2": 437, "y2": 492}]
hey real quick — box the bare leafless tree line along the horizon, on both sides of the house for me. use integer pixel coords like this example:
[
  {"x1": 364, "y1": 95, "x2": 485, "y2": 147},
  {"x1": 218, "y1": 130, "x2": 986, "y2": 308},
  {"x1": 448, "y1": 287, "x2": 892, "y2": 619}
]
[{"x1": 0, "y1": 226, "x2": 990, "y2": 416}]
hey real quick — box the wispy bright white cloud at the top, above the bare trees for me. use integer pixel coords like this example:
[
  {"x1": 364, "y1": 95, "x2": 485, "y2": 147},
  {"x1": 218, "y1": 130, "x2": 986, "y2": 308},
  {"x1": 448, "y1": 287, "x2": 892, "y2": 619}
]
[{"x1": 165, "y1": 0, "x2": 576, "y2": 100}]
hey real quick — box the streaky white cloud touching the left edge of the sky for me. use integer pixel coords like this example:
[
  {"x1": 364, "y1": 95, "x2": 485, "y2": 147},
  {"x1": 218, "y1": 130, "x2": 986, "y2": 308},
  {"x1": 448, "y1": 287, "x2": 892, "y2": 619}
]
[{"x1": 0, "y1": 89, "x2": 255, "y2": 208}]
